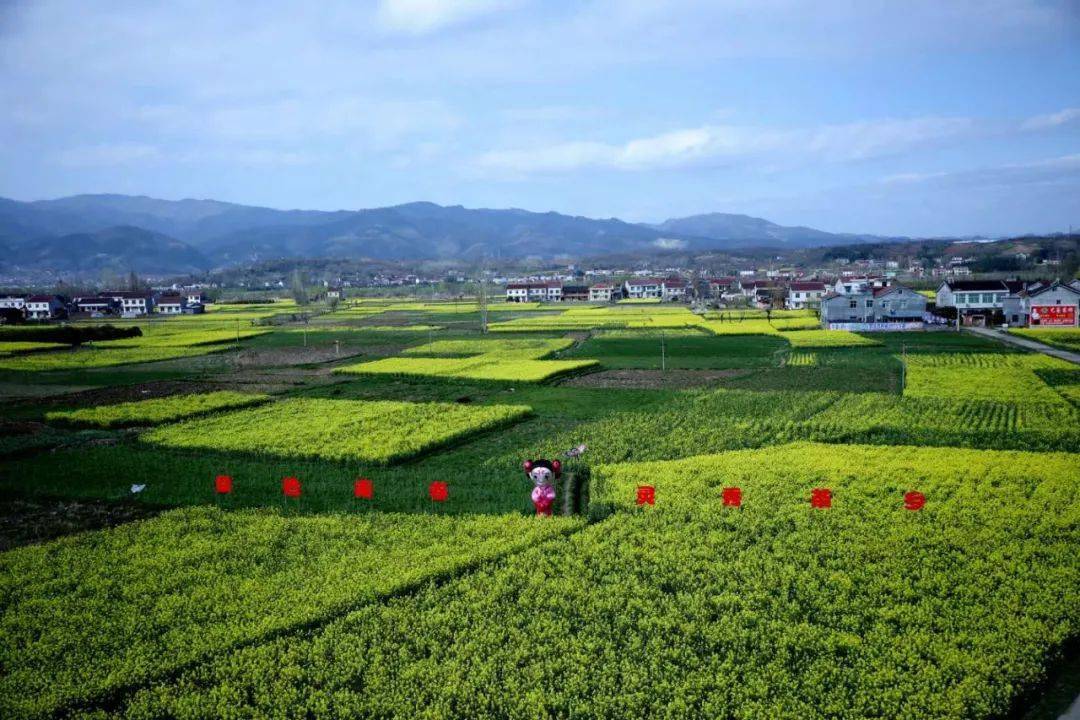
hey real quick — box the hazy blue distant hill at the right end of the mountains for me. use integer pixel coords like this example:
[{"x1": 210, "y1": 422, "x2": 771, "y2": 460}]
[{"x1": 652, "y1": 213, "x2": 907, "y2": 247}]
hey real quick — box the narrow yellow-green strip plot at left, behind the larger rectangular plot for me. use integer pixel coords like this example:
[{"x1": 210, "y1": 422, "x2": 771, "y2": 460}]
[{"x1": 45, "y1": 391, "x2": 270, "y2": 427}]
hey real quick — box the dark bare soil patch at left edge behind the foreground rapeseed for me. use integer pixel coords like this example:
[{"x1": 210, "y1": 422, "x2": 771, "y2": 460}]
[{"x1": 0, "y1": 498, "x2": 164, "y2": 552}]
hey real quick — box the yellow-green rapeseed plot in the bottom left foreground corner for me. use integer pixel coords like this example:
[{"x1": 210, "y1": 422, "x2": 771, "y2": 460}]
[{"x1": 0, "y1": 507, "x2": 580, "y2": 718}]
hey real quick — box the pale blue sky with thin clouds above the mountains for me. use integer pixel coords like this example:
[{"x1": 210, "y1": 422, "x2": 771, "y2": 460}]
[{"x1": 0, "y1": 0, "x2": 1080, "y2": 236}]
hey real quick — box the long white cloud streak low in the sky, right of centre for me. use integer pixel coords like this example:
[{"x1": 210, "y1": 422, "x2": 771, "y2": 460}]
[{"x1": 475, "y1": 118, "x2": 976, "y2": 175}]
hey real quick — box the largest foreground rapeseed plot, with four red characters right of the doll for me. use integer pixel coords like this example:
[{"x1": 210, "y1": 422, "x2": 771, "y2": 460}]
[{"x1": 107, "y1": 445, "x2": 1080, "y2": 719}]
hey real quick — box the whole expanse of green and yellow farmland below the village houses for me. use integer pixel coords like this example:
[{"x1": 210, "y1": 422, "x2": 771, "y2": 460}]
[{"x1": 0, "y1": 299, "x2": 1080, "y2": 718}]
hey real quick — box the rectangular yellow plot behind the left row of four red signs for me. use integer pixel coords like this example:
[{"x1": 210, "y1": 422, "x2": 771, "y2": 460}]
[{"x1": 141, "y1": 398, "x2": 531, "y2": 464}]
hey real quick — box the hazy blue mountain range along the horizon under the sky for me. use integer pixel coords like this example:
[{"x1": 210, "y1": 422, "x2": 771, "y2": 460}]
[{"x1": 0, "y1": 194, "x2": 902, "y2": 274}]
